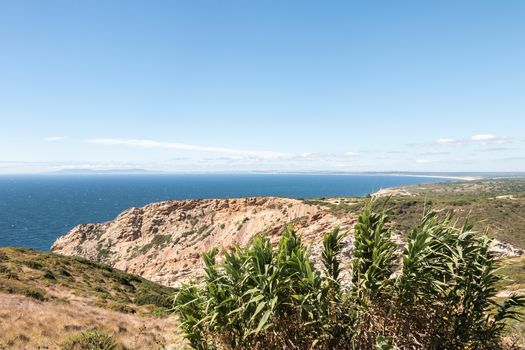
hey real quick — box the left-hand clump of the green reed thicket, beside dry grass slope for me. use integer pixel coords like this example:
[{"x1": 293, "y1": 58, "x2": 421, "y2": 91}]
[{"x1": 176, "y1": 227, "x2": 349, "y2": 349}]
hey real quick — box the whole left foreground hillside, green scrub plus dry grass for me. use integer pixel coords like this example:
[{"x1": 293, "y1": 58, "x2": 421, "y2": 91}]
[{"x1": 0, "y1": 248, "x2": 178, "y2": 350}]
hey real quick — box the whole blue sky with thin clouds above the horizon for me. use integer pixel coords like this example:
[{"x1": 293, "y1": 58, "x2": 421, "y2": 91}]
[{"x1": 0, "y1": 0, "x2": 525, "y2": 173}]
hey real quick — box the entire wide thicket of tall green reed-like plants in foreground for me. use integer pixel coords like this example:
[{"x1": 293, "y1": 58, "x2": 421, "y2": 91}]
[{"x1": 175, "y1": 204, "x2": 525, "y2": 350}]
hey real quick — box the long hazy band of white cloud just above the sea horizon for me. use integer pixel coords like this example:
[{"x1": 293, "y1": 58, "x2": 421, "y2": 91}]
[{"x1": 0, "y1": 132, "x2": 524, "y2": 173}]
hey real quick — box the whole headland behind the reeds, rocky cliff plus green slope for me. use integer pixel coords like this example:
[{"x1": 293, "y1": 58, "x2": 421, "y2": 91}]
[{"x1": 52, "y1": 180, "x2": 525, "y2": 286}]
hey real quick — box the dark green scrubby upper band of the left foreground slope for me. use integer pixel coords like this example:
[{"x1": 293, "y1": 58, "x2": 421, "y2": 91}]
[{"x1": 0, "y1": 248, "x2": 175, "y2": 316}]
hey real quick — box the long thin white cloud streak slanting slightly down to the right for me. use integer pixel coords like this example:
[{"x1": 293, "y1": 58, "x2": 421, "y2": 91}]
[{"x1": 86, "y1": 138, "x2": 287, "y2": 158}]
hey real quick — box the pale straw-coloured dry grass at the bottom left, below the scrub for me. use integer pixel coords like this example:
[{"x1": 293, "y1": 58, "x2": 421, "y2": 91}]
[{"x1": 0, "y1": 293, "x2": 180, "y2": 350}]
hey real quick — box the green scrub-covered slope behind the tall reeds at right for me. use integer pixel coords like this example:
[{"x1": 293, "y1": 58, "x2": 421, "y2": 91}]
[{"x1": 305, "y1": 178, "x2": 525, "y2": 340}]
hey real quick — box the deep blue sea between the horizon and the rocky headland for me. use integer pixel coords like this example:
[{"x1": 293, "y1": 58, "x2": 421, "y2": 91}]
[{"x1": 0, "y1": 175, "x2": 450, "y2": 250}]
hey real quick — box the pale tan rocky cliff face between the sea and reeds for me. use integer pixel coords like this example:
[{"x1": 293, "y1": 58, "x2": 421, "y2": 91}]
[{"x1": 51, "y1": 197, "x2": 356, "y2": 286}]
